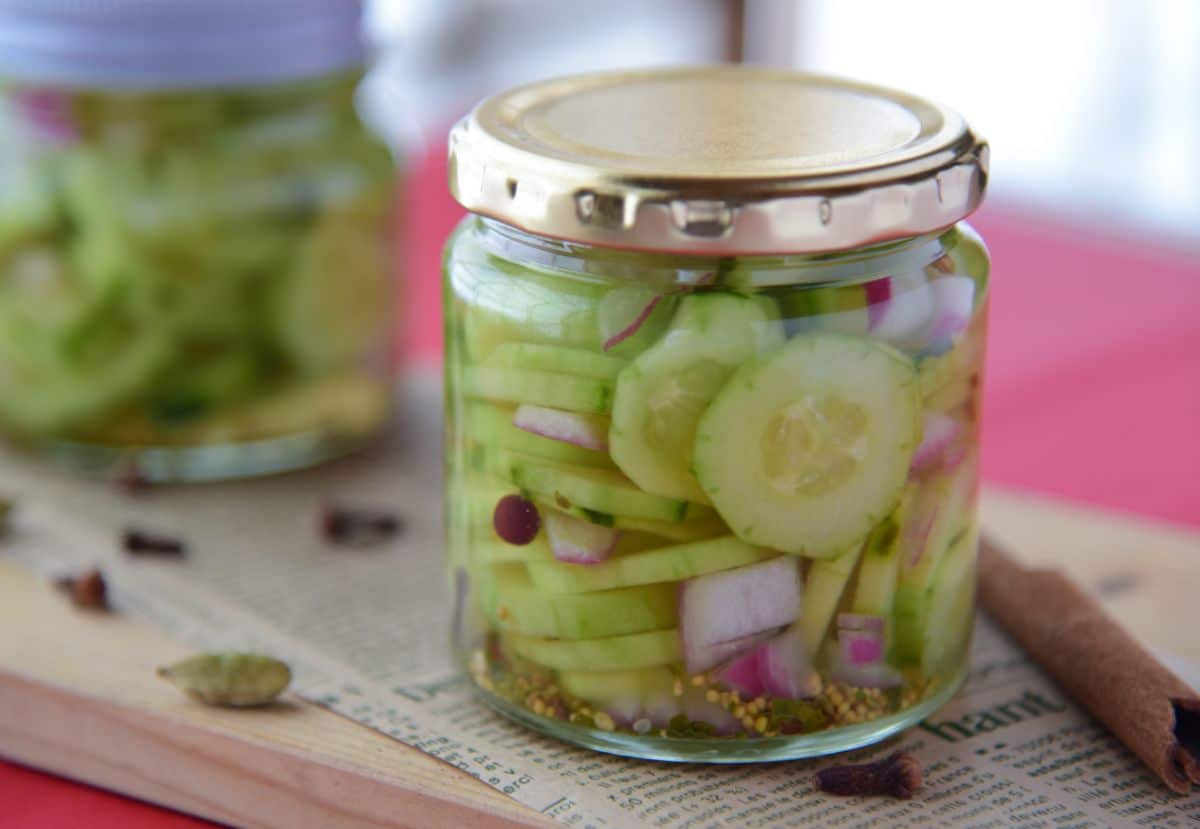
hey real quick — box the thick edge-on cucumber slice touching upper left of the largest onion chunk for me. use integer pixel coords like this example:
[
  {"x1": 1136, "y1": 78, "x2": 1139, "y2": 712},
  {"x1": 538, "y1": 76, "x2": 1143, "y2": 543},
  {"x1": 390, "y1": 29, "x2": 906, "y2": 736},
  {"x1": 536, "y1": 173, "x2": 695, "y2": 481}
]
[{"x1": 491, "y1": 569, "x2": 679, "y2": 639}]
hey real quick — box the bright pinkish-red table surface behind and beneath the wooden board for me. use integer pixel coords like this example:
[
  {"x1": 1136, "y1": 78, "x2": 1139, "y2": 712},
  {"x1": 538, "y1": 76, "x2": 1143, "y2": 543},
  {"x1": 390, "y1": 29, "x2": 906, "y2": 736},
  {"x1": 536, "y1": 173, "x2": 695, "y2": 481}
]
[{"x1": 0, "y1": 145, "x2": 1200, "y2": 829}]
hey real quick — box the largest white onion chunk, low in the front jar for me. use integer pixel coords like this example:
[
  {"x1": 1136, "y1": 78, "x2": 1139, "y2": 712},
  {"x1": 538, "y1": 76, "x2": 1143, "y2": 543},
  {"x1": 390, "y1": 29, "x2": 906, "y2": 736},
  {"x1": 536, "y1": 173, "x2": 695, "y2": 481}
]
[{"x1": 679, "y1": 557, "x2": 803, "y2": 673}]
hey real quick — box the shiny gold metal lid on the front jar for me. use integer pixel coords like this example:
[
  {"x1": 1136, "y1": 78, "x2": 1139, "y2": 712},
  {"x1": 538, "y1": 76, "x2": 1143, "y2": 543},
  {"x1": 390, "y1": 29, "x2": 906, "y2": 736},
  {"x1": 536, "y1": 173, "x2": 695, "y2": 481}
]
[{"x1": 450, "y1": 66, "x2": 988, "y2": 254}]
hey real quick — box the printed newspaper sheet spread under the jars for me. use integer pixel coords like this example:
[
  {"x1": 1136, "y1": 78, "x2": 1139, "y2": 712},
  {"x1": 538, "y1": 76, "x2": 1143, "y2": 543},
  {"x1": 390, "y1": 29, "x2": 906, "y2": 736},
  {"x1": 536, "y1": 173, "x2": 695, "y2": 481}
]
[{"x1": 0, "y1": 378, "x2": 1200, "y2": 829}]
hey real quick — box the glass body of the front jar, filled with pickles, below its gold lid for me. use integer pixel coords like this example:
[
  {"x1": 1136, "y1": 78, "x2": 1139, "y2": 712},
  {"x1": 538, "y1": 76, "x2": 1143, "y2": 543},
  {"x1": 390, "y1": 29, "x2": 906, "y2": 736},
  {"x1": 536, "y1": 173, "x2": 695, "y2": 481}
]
[{"x1": 445, "y1": 217, "x2": 989, "y2": 762}]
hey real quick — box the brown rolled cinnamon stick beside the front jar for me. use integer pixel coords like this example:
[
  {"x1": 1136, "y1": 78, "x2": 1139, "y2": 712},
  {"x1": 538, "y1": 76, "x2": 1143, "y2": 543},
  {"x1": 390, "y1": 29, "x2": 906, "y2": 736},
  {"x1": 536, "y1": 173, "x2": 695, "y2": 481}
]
[{"x1": 979, "y1": 539, "x2": 1200, "y2": 794}]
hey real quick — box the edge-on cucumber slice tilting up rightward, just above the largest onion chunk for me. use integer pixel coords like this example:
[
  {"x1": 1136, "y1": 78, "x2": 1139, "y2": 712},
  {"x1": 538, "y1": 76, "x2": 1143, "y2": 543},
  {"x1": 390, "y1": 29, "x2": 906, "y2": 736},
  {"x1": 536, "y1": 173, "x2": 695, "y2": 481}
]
[{"x1": 529, "y1": 535, "x2": 779, "y2": 593}]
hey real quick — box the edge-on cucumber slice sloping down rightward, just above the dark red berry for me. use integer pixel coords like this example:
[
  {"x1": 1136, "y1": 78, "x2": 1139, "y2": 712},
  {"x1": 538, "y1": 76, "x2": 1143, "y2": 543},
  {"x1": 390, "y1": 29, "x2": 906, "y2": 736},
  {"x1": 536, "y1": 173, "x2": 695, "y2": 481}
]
[{"x1": 487, "y1": 449, "x2": 712, "y2": 524}]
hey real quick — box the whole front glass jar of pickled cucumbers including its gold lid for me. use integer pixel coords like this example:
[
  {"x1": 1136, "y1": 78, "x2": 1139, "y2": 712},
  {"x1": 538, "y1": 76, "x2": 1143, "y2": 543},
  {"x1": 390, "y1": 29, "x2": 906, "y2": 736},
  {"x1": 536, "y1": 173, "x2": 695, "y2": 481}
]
[{"x1": 445, "y1": 67, "x2": 989, "y2": 762}]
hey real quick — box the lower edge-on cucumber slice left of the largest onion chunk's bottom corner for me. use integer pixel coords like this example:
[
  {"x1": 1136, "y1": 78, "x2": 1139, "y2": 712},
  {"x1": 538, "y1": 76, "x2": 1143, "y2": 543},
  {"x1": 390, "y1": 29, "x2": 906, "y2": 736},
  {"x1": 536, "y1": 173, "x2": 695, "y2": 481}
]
[{"x1": 509, "y1": 629, "x2": 683, "y2": 671}]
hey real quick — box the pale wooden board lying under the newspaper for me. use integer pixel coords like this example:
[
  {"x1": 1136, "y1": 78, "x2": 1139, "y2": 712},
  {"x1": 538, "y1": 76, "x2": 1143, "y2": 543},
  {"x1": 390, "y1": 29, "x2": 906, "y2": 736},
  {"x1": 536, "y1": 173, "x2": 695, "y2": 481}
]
[{"x1": 0, "y1": 489, "x2": 1200, "y2": 829}]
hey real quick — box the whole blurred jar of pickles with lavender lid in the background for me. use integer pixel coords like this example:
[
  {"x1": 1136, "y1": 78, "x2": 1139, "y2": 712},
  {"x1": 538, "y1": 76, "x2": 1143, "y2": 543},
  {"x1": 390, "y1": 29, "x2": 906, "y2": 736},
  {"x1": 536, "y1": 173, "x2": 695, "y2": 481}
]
[{"x1": 0, "y1": 0, "x2": 395, "y2": 480}]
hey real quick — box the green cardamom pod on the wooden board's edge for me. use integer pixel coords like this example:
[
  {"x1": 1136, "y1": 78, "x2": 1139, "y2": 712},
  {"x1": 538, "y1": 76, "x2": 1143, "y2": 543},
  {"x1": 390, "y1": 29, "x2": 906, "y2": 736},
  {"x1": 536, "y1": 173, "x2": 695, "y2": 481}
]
[{"x1": 158, "y1": 653, "x2": 292, "y2": 708}]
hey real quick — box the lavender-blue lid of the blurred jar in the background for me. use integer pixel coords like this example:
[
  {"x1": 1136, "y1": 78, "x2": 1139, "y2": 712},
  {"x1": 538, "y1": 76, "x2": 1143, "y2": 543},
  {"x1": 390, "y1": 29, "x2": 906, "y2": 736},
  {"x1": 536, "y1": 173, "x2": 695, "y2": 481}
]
[{"x1": 0, "y1": 0, "x2": 366, "y2": 91}]
